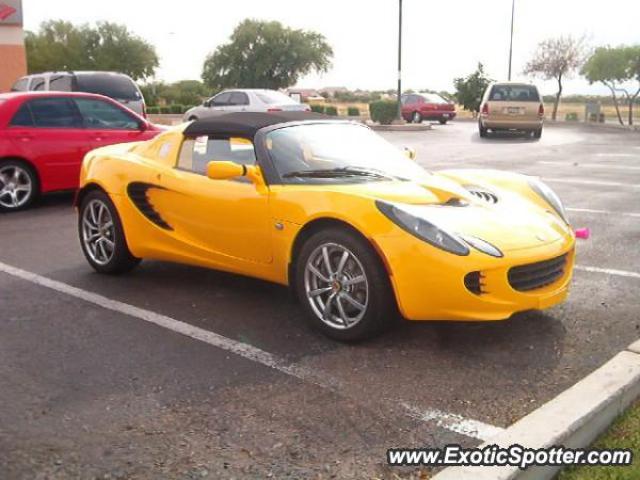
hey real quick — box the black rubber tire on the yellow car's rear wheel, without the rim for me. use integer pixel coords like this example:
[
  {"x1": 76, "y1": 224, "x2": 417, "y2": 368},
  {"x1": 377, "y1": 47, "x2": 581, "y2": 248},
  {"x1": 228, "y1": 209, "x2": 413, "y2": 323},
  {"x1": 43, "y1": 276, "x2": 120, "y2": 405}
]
[{"x1": 78, "y1": 190, "x2": 140, "y2": 274}]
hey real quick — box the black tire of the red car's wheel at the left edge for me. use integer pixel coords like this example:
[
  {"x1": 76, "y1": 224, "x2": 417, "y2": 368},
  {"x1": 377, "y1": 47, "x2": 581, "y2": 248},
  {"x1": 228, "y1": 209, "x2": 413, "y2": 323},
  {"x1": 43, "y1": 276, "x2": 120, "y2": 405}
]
[{"x1": 0, "y1": 160, "x2": 40, "y2": 212}]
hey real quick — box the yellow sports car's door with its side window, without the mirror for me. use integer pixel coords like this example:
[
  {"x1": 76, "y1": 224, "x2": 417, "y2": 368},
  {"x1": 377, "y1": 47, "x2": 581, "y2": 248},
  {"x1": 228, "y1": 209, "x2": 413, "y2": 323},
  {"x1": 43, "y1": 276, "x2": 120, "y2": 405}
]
[{"x1": 156, "y1": 137, "x2": 273, "y2": 266}]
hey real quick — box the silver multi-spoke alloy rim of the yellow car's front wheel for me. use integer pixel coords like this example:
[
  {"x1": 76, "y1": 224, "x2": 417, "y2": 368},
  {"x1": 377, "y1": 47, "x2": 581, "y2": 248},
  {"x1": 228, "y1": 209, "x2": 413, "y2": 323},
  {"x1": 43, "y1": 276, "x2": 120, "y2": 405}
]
[{"x1": 304, "y1": 243, "x2": 369, "y2": 330}]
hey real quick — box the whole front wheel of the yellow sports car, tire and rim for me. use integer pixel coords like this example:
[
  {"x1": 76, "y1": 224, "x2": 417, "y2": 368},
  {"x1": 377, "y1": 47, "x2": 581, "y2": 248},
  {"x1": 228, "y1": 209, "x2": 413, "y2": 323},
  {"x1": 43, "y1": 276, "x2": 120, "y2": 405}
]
[{"x1": 295, "y1": 228, "x2": 397, "y2": 341}]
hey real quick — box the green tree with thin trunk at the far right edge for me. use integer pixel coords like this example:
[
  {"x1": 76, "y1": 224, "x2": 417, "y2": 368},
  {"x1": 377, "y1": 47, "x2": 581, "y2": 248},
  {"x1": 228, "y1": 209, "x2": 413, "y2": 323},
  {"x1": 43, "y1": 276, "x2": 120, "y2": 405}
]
[{"x1": 580, "y1": 47, "x2": 629, "y2": 125}]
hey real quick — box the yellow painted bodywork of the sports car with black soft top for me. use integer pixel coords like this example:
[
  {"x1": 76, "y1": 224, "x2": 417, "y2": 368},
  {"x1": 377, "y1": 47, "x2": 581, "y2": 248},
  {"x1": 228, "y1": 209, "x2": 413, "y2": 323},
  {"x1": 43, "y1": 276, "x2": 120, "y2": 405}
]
[{"x1": 81, "y1": 127, "x2": 575, "y2": 320}]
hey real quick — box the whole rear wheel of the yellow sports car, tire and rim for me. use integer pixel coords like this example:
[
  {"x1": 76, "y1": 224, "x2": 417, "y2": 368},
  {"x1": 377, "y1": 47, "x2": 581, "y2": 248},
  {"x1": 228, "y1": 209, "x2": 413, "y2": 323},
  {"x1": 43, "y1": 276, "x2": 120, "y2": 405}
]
[{"x1": 78, "y1": 190, "x2": 140, "y2": 274}]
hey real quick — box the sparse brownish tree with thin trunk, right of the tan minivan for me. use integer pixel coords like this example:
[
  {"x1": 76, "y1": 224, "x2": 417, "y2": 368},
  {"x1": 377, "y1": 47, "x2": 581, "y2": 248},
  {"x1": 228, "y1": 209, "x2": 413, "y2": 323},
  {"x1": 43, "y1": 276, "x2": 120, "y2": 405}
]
[{"x1": 524, "y1": 36, "x2": 584, "y2": 120}]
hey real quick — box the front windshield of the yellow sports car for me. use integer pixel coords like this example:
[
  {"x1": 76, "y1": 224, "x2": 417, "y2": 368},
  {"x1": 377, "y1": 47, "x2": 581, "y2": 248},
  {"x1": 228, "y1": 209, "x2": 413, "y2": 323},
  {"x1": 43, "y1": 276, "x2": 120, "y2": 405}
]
[{"x1": 266, "y1": 123, "x2": 429, "y2": 183}]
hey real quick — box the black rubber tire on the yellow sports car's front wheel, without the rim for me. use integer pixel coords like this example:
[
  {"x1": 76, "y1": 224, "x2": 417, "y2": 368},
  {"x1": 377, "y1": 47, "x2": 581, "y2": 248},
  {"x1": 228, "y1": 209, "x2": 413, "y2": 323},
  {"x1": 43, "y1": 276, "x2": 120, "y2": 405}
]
[{"x1": 295, "y1": 227, "x2": 399, "y2": 342}]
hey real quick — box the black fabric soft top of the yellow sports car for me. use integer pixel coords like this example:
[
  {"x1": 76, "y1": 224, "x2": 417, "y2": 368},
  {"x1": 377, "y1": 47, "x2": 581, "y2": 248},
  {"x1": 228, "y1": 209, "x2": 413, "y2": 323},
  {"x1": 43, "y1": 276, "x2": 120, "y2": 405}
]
[{"x1": 184, "y1": 112, "x2": 332, "y2": 140}]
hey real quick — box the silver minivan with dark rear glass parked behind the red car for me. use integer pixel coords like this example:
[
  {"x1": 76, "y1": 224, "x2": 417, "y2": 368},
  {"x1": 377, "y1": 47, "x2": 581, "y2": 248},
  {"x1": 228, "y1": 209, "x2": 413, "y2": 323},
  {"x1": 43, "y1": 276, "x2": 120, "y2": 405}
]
[{"x1": 11, "y1": 72, "x2": 147, "y2": 117}]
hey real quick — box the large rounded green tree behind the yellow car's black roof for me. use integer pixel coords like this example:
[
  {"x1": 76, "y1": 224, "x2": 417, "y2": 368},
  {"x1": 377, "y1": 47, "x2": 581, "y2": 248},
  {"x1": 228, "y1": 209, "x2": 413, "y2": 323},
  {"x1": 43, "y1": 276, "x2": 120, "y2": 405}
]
[{"x1": 202, "y1": 20, "x2": 333, "y2": 89}]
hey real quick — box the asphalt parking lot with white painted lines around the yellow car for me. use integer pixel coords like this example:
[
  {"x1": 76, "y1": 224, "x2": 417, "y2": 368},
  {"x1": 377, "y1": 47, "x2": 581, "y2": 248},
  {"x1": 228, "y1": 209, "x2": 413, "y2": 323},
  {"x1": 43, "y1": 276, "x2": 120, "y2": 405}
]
[{"x1": 0, "y1": 122, "x2": 640, "y2": 478}]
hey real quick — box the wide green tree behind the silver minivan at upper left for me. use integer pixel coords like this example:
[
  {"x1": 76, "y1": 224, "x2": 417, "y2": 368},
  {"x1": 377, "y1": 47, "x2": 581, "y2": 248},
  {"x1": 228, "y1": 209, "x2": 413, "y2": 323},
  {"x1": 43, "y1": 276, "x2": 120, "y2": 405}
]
[{"x1": 25, "y1": 20, "x2": 158, "y2": 80}]
